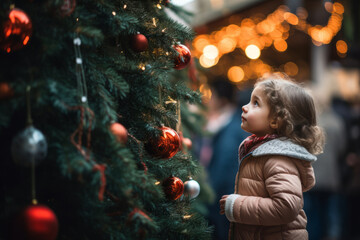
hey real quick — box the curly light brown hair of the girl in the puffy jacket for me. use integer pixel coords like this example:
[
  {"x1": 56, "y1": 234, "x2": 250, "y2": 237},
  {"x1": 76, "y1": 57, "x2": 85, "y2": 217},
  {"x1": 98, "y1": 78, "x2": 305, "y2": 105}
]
[{"x1": 255, "y1": 77, "x2": 325, "y2": 154}]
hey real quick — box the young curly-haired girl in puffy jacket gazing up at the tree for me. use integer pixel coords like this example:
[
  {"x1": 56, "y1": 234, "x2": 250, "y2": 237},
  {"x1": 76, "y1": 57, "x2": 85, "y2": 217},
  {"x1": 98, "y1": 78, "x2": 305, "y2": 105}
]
[{"x1": 220, "y1": 79, "x2": 324, "y2": 240}]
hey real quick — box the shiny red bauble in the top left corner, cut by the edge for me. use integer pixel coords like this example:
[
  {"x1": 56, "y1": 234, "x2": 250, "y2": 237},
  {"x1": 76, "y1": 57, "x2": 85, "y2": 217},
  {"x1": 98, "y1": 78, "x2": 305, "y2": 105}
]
[{"x1": 0, "y1": 8, "x2": 32, "y2": 53}]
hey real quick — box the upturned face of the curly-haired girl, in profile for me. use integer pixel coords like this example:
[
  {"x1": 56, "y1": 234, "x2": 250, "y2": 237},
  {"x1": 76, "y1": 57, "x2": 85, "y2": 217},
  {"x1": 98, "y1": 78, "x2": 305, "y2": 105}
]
[{"x1": 241, "y1": 85, "x2": 277, "y2": 137}]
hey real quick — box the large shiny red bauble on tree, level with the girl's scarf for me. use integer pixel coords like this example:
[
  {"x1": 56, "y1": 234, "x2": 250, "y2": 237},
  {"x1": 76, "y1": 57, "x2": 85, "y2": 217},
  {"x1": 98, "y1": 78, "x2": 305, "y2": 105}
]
[{"x1": 145, "y1": 127, "x2": 180, "y2": 159}]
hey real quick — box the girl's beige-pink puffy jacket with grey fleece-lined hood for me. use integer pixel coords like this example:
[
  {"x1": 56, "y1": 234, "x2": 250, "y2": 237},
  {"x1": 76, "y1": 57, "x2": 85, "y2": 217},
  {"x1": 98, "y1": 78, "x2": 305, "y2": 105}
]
[{"x1": 225, "y1": 139, "x2": 316, "y2": 240}]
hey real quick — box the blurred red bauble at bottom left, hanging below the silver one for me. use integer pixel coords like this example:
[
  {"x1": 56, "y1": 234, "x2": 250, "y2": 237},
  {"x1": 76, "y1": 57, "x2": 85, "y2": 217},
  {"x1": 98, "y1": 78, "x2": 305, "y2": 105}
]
[{"x1": 13, "y1": 205, "x2": 59, "y2": 240}]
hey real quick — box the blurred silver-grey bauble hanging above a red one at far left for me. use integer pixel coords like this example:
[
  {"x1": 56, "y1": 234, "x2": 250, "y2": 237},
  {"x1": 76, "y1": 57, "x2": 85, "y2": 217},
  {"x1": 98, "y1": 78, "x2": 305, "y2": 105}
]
[{"x1": 11, "y1": 126, "x2": 47, "y2": 166}]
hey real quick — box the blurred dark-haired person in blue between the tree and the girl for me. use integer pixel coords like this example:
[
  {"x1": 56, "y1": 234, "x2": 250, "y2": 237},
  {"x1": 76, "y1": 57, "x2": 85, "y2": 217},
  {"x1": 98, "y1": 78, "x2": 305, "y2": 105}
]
[{"x1": 200, "y1": 78, "x2": 250, "y2": 240}]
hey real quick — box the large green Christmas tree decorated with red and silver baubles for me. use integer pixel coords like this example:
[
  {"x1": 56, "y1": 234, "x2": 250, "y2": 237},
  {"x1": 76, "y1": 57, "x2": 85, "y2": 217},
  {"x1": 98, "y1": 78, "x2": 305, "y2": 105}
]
[{"x1": 0, "y1": 0, "x2": 210, "y2": 240}]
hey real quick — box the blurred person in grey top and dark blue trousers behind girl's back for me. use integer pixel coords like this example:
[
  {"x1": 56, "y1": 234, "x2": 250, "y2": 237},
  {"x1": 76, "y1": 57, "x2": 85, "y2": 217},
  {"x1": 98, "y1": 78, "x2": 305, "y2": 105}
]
[{"x1": 304, "y1": 87, "x2": 346, "y2": 240}]
